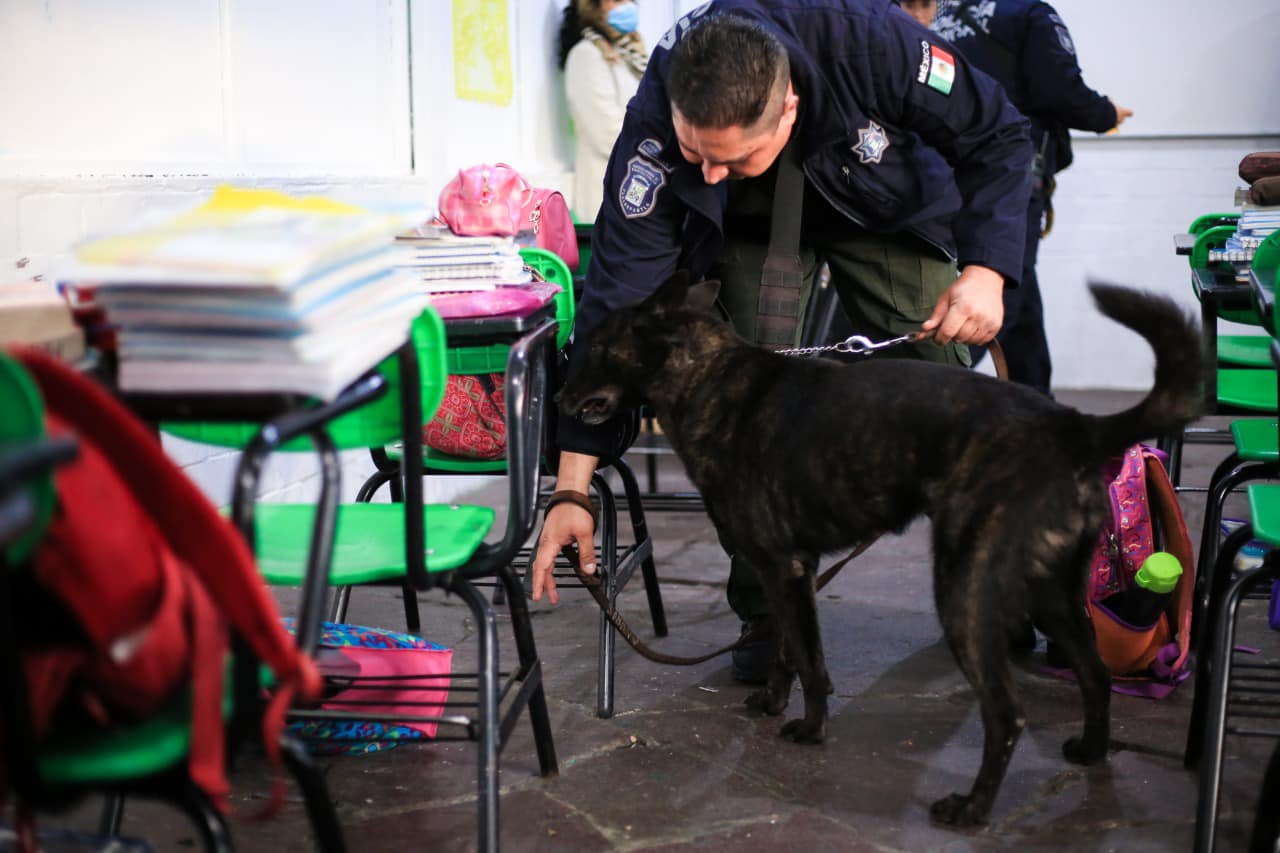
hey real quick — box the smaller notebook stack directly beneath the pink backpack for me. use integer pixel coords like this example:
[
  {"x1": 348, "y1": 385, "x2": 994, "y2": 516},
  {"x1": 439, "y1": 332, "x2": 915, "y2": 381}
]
[{"x1": 396, "y1": 223, "x2": 531, "y2": 295}]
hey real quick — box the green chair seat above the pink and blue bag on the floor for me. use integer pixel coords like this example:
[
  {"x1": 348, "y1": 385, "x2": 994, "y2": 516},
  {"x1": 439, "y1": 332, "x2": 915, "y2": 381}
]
[{"x1": 255, "y1": 503, "x2": 495, "y2": 587}]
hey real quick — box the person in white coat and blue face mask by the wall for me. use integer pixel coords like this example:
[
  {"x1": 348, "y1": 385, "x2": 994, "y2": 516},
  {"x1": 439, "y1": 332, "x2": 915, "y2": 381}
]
[{"x1": 559, "y1": 0, "x2": 648, "y2": 222}]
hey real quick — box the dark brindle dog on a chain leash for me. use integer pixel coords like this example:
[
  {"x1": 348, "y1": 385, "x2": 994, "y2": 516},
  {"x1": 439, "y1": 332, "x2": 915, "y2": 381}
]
[{"x1": 559, "y1": 273, "x2": 1203, "y2": 826}]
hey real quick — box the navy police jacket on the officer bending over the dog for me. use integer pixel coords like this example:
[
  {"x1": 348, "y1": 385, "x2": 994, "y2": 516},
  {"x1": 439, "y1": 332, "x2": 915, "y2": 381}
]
[{"x1": 558, "y1": 0, "x2": 1032, "y2": 457}]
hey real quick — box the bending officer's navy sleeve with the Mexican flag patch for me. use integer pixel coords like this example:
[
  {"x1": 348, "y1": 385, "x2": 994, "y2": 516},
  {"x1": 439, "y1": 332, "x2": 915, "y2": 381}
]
[{"x1": 872, "y1": 8, "x2": 1033, "y2": 284}]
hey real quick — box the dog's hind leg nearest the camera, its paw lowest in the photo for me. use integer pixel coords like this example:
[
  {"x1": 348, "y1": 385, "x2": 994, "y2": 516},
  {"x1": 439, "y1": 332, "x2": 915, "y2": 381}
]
[{"x1": 929, "y1": 549, "x2": 1025, "y2": 826}]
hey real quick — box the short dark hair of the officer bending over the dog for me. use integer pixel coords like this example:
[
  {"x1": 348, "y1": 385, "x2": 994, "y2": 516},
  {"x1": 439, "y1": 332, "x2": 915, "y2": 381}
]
[{"x1": 667, "y1": 14, "x2": 791, "y2": 128}]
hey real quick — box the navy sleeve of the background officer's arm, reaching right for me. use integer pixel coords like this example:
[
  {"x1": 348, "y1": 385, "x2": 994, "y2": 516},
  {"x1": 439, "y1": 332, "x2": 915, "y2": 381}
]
[{"x1": 1019, "y1": 3, "x2": 1116, "y2": 133}]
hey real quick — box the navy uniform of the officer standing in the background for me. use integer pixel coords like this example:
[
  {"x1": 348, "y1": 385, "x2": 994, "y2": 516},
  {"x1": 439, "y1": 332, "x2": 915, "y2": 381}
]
[{"x1": 933, "y1": 0, "x2": 1116, "y2": 393}]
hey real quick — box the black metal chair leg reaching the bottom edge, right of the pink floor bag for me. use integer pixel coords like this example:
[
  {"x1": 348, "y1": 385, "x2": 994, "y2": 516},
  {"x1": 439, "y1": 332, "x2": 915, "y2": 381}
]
[{"x1": 449, "y1": 574, "x2": 499, "y2": 853}]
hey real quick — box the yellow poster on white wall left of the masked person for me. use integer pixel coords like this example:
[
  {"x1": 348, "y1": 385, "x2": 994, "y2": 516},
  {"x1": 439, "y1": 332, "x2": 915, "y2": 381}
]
[{"x1": 453, "y1": 0, "x2": 513, "y2": 106}]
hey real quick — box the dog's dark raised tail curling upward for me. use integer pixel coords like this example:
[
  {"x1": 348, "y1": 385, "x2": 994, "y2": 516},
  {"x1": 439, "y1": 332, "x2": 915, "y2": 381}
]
[{"x1": 1089, "y1": 282, "x2": 1204, "y2": 455}]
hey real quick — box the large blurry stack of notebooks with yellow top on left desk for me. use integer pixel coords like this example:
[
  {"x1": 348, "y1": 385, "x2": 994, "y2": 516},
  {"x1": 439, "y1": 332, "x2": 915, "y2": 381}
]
[{"x1": 59, "y1": 187, "x2": 425, "y2": 400}]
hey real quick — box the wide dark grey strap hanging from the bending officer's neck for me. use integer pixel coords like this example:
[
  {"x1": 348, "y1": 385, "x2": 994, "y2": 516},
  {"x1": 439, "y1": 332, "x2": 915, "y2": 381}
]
[{"x1": 755, "y1": 136, "x2": 804, "y2": 348}]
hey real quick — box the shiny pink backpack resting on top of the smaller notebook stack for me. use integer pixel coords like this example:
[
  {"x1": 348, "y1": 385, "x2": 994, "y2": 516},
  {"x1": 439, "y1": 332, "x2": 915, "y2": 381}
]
[{"x1": 438, "y1": 163, "x2": 579, "y2": 270}]
